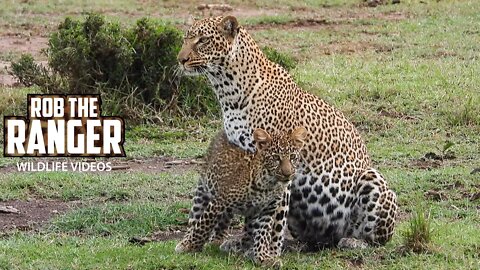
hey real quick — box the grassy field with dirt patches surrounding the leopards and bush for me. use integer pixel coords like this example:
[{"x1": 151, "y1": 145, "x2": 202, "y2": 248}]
[{"x1": 0, "y1": 0, "x2": 480, "y2": 269}]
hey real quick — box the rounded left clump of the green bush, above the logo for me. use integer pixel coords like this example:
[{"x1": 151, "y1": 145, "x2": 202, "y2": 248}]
[{"x1": 47, "y1": 14, "x2": 136, "y2": 94}]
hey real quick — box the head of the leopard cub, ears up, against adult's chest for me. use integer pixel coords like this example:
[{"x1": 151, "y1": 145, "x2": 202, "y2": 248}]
[{"x1": 253, "y1": 127, "x2": 307, "y2": 182}]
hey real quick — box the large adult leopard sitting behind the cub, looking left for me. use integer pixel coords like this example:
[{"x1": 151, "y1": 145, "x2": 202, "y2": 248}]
[{"x1": 178, "y1": 16, "x2": 397, "y2": 248}]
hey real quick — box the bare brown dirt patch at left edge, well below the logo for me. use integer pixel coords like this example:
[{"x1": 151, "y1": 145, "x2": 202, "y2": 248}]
[{"x1": 0, "y1": 200, "x2": 76, "y2": 233}]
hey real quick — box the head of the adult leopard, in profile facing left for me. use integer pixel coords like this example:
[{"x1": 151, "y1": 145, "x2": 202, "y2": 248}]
[{"x1": 177, "y1": 16, "x2": 239, "y2": 75}]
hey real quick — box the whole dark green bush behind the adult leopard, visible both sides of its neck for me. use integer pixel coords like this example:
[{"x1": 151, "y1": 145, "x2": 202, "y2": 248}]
[{"x1": 12, "y1": 14, "x2": 295, "y2": 122}]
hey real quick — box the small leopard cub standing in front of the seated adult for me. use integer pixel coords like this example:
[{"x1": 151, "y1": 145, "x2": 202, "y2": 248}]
[{"x1": 175, "y1": 127, "x2": 307, "y2": 263}]
